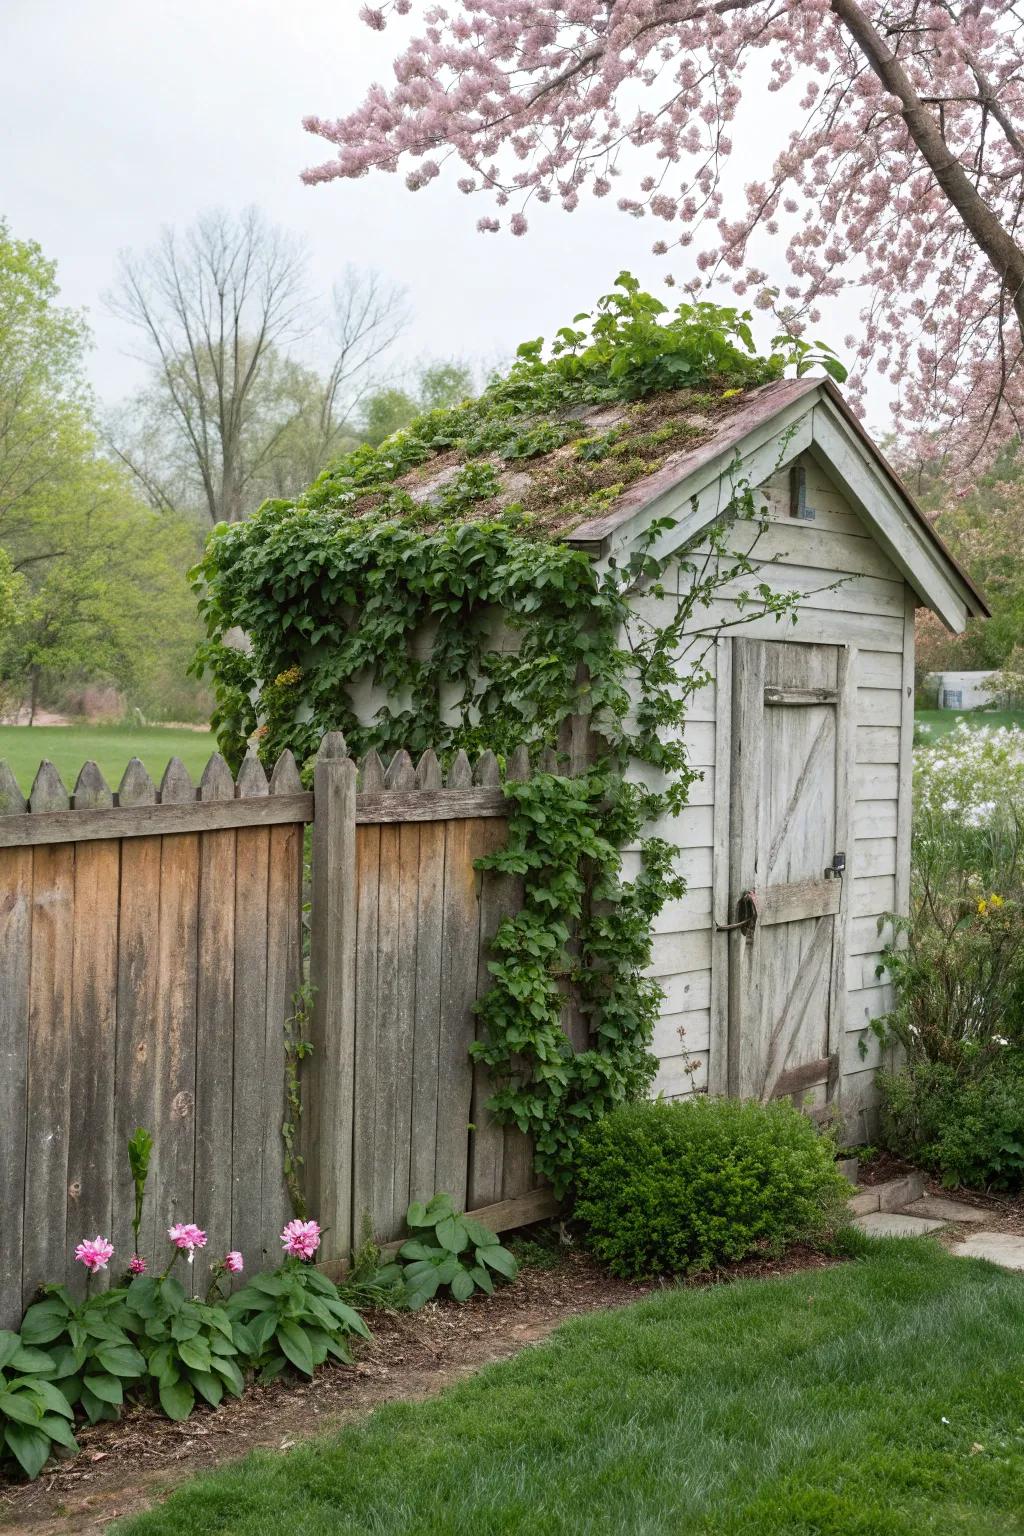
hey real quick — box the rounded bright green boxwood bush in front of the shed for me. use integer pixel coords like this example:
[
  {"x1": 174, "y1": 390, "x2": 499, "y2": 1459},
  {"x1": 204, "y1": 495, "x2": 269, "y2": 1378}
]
[{"x1": 576, "y1": 1097, "x2": 849, "y2": 1279}]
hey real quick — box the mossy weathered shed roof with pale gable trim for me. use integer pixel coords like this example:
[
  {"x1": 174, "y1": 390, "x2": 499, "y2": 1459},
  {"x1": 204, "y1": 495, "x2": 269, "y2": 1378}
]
[{"x1": 317, "y1": 378, "x2": 989, "y2": 631}]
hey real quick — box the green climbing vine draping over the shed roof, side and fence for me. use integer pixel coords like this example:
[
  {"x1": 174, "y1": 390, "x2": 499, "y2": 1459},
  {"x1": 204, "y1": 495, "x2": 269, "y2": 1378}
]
[{"x1": 193, "y1": 282, "x2": 835, "y2": 1190}]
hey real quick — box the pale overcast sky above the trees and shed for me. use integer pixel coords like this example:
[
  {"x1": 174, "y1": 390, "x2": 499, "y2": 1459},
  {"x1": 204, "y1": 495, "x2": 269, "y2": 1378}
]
[{"x1": 0, "y1": 0, "x2": 884, "y2": 423}]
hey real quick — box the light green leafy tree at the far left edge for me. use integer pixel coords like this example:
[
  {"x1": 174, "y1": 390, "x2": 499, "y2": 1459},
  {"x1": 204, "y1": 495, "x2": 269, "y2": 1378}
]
[{"x1": 0, "y1": 224, "x2": 205, "y2": 716}]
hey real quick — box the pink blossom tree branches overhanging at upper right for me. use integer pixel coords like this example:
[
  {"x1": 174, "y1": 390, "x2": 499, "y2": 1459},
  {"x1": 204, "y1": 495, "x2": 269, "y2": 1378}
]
[{"x1": 304, "y1": 0, "x2": 1024, "y2": 464}]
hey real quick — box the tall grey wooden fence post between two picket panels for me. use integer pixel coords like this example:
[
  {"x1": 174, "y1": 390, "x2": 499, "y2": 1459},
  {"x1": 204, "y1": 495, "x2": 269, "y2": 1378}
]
[{"x1": 302, "y1": 731, "x2": 356, "y2": 1261}]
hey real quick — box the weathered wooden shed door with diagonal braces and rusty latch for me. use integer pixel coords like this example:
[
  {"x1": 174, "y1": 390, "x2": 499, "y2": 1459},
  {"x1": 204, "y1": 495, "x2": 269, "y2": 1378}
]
[{"x1": 729, "y1": 641, "x2": 851, "y2": 1109}]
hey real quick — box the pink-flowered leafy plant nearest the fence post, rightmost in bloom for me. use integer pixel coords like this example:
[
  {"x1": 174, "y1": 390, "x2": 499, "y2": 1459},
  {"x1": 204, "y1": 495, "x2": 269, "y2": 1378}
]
[{"x1": 224, "y1": 1220, "x2": 370, "y2": 1381}]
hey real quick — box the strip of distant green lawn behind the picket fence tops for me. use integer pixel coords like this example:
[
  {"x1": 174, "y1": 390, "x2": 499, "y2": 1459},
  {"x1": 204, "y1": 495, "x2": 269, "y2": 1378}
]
[{"x1": 0, "y1": 725, "x2": 216, "y2": 794}]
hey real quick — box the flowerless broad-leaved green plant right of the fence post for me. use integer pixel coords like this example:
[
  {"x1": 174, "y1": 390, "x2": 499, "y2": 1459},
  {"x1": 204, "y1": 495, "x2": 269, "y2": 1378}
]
[{"x1": 393, "y1": 1193, "x2": 519, "y2": 1312}]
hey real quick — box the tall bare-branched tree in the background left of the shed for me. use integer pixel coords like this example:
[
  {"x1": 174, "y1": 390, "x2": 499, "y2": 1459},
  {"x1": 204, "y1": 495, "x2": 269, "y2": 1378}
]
[{"x1": 109, "y1": 209, "x2": 407, "y2": 524}]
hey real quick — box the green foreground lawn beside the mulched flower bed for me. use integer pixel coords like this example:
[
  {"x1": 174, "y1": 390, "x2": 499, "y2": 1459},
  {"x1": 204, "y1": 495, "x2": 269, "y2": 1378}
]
[{"x1": 118, "y1": 1240, "x2": 1024, "y2": 1536}]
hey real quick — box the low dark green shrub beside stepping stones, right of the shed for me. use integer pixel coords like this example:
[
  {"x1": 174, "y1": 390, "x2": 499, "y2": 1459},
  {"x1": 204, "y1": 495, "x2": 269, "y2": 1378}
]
[{"x1": 878, "y1": 1048, "x2": 1024, "y2": 1189}]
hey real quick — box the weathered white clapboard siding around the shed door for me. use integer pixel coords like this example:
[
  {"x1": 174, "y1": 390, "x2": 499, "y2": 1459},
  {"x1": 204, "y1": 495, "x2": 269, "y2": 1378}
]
[{"x1": 641, "y1": 455, "x2": 913, "y2": 1129}]
